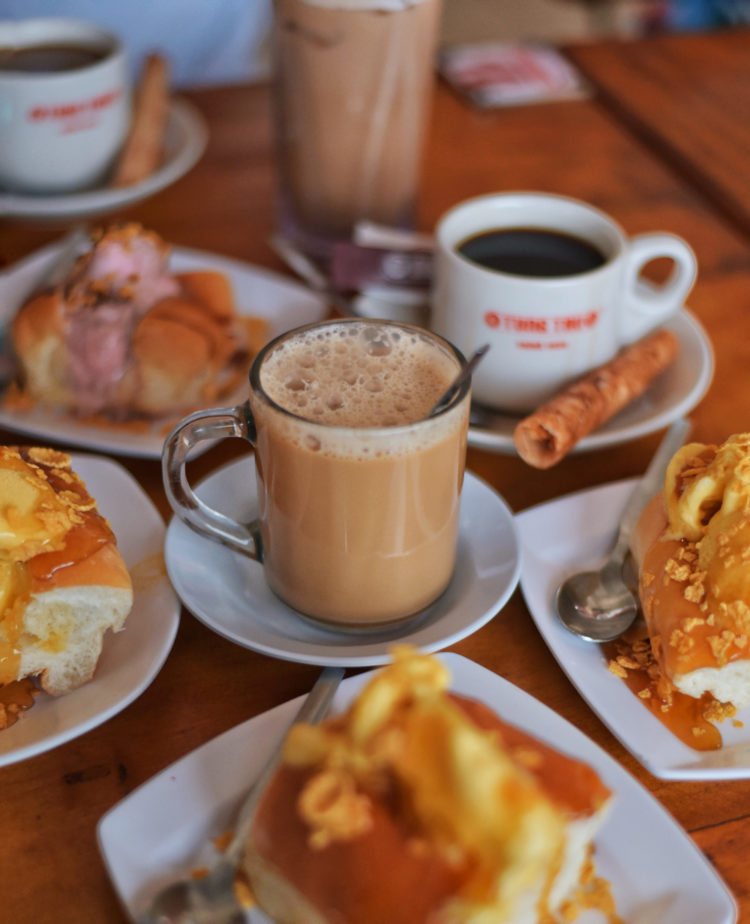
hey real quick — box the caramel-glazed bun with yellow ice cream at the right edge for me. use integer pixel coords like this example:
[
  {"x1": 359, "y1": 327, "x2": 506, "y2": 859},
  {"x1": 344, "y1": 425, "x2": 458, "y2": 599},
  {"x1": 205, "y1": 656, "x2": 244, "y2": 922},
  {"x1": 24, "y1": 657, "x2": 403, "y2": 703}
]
[{"x1": 631, "y1": 434, "x2": 750, "y2": 708}]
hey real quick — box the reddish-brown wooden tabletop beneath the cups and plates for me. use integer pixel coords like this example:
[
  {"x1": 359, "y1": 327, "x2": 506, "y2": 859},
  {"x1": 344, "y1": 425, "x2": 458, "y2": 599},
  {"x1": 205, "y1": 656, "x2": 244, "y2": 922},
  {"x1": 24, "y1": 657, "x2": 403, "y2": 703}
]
[{"x1": 0, "y1": 28, "x2": 750, "y2": 924}]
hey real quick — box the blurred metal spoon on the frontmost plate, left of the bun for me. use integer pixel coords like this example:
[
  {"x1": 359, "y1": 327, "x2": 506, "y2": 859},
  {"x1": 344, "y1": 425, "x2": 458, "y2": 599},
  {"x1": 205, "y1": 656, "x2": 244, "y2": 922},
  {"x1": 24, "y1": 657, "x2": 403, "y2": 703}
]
[{"x1": 137, "y1": 667, "x2": 344, "y2": 924}]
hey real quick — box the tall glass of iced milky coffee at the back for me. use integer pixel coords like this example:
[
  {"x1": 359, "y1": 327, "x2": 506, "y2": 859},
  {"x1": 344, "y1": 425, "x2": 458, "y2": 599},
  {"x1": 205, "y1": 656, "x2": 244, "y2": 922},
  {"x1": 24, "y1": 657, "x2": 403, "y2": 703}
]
[{"x1": 275, "y1": 0, "x2": 440, "y2": 255}]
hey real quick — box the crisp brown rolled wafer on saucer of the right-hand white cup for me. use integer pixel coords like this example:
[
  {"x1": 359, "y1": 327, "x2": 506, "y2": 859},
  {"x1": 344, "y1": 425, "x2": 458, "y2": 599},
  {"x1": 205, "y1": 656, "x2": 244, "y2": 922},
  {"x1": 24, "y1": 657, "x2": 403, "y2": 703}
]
[{"x1": 513, "y1": 330, "x2": 678, "y2": 468}]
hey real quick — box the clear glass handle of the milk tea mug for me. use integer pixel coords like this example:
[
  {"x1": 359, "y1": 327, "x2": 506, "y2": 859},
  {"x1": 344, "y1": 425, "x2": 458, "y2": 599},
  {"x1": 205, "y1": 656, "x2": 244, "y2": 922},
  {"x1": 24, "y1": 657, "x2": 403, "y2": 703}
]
[{"x1": 162, "y1": 402, "x2": 261, "y2": 561}]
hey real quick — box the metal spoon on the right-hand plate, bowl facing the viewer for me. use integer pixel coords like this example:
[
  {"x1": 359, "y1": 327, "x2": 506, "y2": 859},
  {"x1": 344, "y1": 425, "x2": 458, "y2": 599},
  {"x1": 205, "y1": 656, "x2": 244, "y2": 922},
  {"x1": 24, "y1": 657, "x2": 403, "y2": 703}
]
[{"x1": 555, "y1": 419, "x2": 690, "y2": 642}]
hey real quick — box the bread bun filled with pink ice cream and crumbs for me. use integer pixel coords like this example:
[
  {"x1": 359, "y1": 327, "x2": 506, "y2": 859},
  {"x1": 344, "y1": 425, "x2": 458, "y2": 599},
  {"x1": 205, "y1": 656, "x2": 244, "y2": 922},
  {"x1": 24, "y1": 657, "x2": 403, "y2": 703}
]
[{"x1": 11, "y1": 224, "x2": 268, "y2": 419}]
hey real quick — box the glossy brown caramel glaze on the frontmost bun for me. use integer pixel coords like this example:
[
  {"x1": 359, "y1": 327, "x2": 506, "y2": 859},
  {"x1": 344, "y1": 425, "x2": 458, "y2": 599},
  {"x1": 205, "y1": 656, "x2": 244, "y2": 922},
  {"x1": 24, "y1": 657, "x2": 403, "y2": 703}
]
[{"x1": 254, "y1": 696, "x2": 609, "y2": 924}]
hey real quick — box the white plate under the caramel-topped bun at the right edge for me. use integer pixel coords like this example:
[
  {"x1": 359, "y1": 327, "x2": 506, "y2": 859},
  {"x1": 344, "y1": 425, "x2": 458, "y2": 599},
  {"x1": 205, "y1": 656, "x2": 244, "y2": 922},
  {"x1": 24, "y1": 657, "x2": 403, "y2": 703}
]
[{"x1": 516, "y1": 479, "x2": 750, "y2": 780}]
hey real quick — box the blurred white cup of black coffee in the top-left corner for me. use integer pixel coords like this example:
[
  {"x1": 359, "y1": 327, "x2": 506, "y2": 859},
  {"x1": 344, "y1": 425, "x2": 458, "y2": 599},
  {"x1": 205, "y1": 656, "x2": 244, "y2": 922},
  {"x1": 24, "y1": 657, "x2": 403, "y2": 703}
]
[{"x1": 0, "y1": 19, "x2": 130, "y2": 193}]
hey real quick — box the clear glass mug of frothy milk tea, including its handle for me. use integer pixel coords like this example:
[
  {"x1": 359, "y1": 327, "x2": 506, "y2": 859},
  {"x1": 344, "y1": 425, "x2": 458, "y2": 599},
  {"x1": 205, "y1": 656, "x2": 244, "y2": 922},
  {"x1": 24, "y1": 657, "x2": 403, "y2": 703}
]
[{"x1": 163, "y1": 318, "x2": 470, "y2": 628}]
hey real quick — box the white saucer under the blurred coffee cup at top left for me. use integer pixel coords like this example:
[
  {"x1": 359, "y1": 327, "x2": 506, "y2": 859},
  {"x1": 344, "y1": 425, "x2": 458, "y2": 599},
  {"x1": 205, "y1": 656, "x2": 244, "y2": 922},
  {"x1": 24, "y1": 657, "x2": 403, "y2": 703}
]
[{"x1": 0, "y1": 99, "x2": 208, "y2": 221}]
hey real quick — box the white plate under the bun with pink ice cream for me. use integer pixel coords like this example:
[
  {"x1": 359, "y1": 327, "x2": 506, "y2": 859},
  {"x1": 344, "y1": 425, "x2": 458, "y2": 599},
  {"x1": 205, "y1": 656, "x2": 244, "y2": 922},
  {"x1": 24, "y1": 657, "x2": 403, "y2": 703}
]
[{"x1": 0, "y1": 243, "x2": 328, "y2": 459}]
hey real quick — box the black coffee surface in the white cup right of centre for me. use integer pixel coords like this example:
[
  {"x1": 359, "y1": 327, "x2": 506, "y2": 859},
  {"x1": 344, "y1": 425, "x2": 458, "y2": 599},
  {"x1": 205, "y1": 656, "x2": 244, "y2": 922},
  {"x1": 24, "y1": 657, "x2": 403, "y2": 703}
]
[{"x1": 456, "y1": 228, "x2": 607, "y2": 277}]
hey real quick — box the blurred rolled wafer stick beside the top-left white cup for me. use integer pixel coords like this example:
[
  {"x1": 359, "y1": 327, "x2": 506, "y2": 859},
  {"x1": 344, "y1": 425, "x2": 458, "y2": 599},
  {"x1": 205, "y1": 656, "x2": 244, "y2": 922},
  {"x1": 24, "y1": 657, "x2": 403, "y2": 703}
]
[{"x1": 112, "y1": 54, "x2": 169, "y2": 186}]
